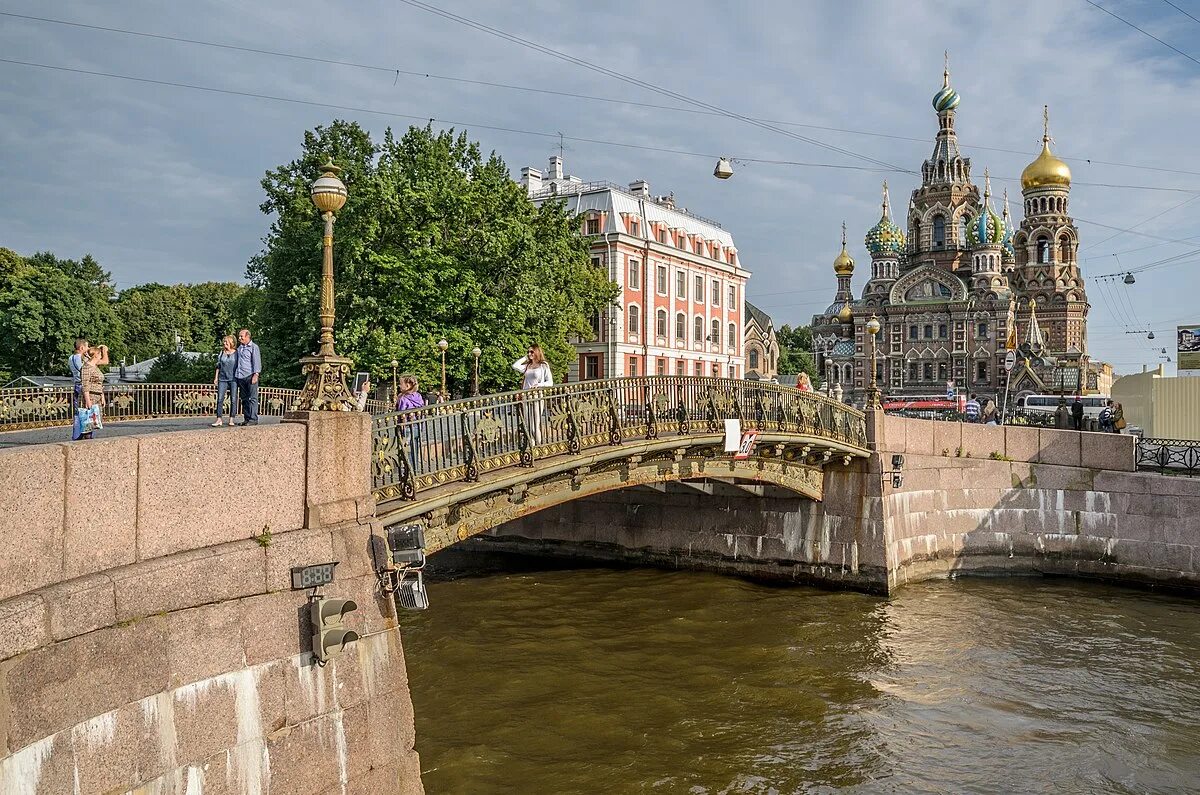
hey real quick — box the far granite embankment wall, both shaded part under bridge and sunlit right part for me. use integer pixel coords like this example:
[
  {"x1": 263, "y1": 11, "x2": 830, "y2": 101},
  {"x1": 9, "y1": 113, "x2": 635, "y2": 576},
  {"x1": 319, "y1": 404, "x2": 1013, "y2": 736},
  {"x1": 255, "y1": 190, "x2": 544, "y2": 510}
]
[{"x1": 480, "y1": 417, "x2": 1200, "y2": 592}]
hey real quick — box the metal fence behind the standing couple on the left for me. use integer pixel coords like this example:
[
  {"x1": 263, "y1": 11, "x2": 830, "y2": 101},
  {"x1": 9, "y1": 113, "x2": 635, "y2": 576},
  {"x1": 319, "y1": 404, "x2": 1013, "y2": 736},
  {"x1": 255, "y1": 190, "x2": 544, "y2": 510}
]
[{"x1": 0, "y1": 383, "x2": 391, "y2": 431}]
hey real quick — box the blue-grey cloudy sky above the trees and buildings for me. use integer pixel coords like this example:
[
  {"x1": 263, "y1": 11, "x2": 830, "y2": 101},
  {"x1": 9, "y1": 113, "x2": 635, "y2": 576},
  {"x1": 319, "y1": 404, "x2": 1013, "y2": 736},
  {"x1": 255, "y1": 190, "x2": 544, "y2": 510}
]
[{"x1": 0, "y1": 0, "x2": 1200, "y2": 372}]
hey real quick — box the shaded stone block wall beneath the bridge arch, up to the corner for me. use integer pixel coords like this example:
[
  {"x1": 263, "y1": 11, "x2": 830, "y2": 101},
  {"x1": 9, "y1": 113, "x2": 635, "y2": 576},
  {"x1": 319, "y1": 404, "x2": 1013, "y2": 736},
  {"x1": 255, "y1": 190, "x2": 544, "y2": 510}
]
[{"x1": 466, "y1": 461, "x2": 887, "y2": 592}]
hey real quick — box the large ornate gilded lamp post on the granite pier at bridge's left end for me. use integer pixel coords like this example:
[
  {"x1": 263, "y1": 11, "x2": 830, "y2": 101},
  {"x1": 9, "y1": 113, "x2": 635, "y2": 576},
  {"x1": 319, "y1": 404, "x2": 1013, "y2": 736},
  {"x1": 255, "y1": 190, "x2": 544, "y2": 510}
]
[{"x1": 296, "y1": 160, "x2": 358, "y2": 411}]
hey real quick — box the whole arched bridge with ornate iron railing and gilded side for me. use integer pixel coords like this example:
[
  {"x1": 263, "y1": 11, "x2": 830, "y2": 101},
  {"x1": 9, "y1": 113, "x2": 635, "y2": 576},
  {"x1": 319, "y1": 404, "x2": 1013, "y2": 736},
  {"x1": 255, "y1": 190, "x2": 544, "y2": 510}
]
[{"x1": 372, "y1": 376, "x2": 868, "y2": 552}]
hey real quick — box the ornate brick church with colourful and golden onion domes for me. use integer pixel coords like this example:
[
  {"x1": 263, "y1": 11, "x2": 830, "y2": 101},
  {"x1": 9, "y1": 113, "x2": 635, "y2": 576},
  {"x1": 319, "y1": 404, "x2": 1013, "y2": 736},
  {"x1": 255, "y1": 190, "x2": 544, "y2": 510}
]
[{"x1": 812, "y1": 64, "x2": 1111, "y2": 405}]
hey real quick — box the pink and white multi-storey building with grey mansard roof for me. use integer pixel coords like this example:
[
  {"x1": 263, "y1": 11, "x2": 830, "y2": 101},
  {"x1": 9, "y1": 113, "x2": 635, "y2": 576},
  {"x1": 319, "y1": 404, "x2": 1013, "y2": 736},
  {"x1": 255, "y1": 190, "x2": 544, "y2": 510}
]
[{"x1": 521, "y1": 156, "x2": 750, "y2": 381}]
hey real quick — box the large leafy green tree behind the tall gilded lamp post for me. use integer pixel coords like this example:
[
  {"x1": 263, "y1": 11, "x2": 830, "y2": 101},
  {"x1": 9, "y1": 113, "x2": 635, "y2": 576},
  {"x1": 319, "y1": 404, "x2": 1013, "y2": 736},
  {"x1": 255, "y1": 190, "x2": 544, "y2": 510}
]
[{"x1": 247, "y1": 120, "x2": 617, "y2": 391}]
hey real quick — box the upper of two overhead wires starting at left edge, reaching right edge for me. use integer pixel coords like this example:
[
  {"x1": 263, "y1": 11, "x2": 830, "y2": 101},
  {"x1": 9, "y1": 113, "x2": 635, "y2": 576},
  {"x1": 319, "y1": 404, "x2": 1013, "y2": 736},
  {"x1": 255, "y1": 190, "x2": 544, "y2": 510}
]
[{"x1": 7, "y1": 11, "x2": 1200, "y2": 177}]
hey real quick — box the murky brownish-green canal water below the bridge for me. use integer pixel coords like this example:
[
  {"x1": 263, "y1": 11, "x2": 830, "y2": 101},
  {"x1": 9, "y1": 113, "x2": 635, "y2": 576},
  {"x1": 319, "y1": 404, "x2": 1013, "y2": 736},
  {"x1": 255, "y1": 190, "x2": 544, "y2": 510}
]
[{"x1": 402, "y1": 559, "x2": 1200, "y2": 795}]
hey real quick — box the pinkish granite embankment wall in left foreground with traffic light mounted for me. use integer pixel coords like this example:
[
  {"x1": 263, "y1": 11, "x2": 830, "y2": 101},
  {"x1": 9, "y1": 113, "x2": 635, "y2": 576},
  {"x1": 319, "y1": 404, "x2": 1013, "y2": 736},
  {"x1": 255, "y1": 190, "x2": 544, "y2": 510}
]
[{"x1": 0, "y1": 414, "x2": 421, "y2": 795}]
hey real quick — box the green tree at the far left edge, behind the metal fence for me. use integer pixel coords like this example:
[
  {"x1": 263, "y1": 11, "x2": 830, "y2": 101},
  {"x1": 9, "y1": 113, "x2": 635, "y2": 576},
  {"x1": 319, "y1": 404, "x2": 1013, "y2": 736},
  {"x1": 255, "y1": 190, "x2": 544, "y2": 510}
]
[{"x1": 0, "y1": 249, "x2": 124, "y2": 375}]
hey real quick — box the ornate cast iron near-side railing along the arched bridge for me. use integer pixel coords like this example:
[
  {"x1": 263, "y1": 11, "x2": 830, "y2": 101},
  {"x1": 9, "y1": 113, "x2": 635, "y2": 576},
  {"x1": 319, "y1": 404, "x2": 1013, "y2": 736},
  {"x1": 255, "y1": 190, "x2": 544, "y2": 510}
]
[{"x1": 372, "y1": 376, "x2": 866, "y2": 502}]
